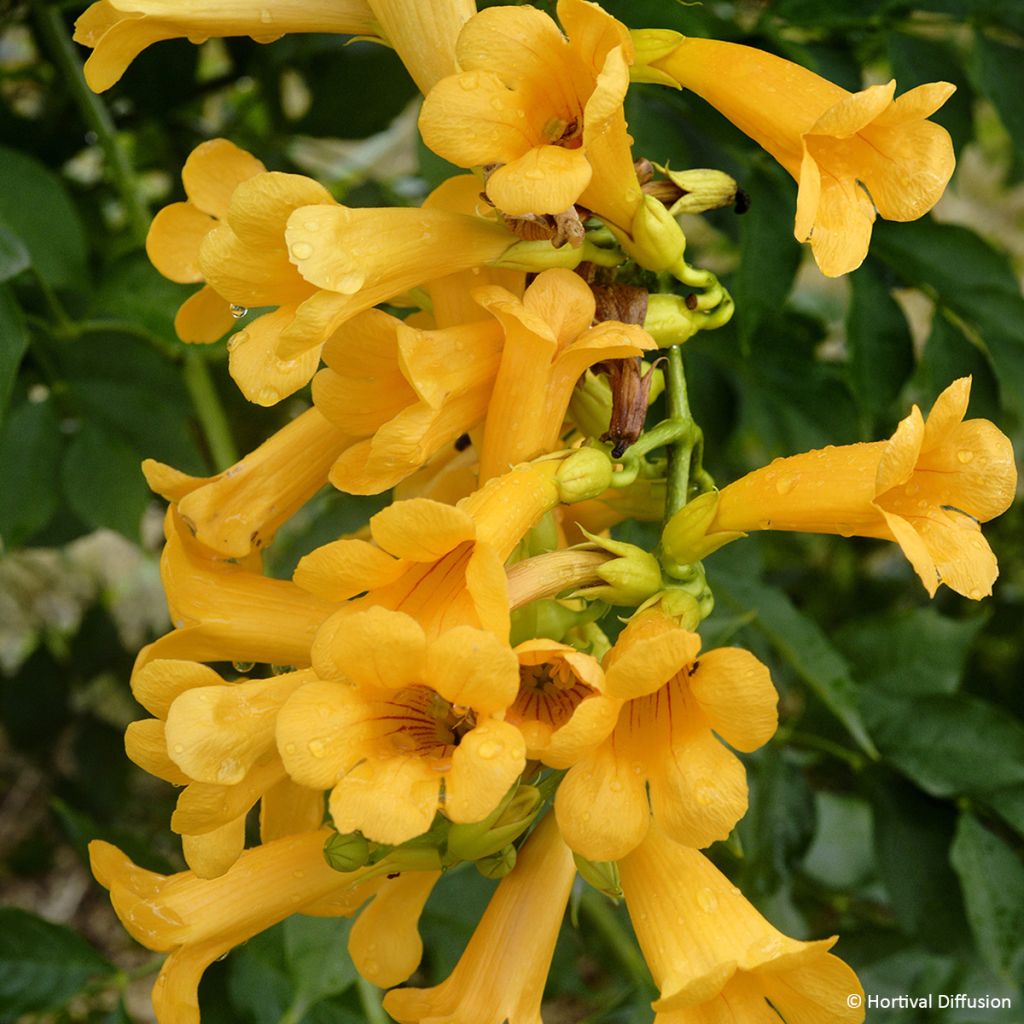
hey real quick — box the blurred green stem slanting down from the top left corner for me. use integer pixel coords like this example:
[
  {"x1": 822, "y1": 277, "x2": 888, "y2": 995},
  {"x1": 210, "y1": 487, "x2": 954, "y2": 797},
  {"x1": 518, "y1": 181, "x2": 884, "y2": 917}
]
[{"x1": 36, "y1": 4, "x2": 150, "y2": 245}]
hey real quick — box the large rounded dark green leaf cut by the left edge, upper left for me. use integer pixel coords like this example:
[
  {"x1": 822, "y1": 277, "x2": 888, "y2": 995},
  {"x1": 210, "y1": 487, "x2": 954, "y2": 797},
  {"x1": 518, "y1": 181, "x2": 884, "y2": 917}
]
[{"x1": 0, "y1": 146, "x2": 86, "y2": 288}]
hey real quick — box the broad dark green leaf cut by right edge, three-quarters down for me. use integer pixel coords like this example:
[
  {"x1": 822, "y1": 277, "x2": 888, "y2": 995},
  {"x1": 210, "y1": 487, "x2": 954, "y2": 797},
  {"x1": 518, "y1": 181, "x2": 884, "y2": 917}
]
[{"x1": 862, "y1": 689, "x2": 1024, "y2": 797}]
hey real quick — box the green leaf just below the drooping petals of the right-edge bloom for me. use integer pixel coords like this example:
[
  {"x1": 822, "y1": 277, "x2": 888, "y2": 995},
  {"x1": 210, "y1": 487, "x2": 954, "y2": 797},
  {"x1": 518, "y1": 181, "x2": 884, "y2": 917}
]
[{"x1": 835, "y1": 608, "x2": 986, "y2": 694}]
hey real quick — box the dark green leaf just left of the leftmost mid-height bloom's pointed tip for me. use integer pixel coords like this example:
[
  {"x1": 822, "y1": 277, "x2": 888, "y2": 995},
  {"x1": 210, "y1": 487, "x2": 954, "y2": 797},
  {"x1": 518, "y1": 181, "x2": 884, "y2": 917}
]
[{"x1": 60, "y1": 422, "x2": 150, "y2": 541}]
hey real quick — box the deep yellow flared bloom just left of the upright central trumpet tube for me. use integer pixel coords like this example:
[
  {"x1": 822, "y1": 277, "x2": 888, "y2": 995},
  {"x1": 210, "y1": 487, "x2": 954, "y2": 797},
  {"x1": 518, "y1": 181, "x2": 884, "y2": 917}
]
[{"x1": 313, "y1": 309, "x2": 504, "y2": 494}]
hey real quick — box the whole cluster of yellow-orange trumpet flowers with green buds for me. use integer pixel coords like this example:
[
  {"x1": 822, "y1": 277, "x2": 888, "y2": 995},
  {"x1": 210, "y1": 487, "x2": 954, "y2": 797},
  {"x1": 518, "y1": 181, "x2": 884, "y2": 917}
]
[{"x1": 77, "y1": 0, "x2": 1016, "y2": 1024}]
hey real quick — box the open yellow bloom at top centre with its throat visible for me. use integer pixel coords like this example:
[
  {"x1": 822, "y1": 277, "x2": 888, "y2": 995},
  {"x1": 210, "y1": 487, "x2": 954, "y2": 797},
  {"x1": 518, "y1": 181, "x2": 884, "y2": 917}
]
[{"x1": 420, "y1": 0, "x2": 640, "y2": 229}]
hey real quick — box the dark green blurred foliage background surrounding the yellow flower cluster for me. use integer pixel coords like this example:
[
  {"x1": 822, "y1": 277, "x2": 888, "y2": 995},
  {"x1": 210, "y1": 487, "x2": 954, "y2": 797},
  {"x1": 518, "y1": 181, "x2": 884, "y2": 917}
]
[{"x1": 0, "y1": 0, "x2": 1024, "y2": 1024}]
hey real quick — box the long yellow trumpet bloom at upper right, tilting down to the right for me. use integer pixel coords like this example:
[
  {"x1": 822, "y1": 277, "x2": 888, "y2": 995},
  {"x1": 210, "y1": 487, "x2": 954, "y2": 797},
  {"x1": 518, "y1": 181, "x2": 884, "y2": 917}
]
[{"x1": 652, "y1": 39, "x2": 955, "y2": 276}]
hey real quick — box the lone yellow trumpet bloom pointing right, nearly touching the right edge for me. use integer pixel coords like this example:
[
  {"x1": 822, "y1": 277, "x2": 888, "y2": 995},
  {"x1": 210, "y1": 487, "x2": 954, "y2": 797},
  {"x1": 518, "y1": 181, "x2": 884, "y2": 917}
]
[{"x1": 679, "y1": 377, "x2": 1017, "y2": 600}]
